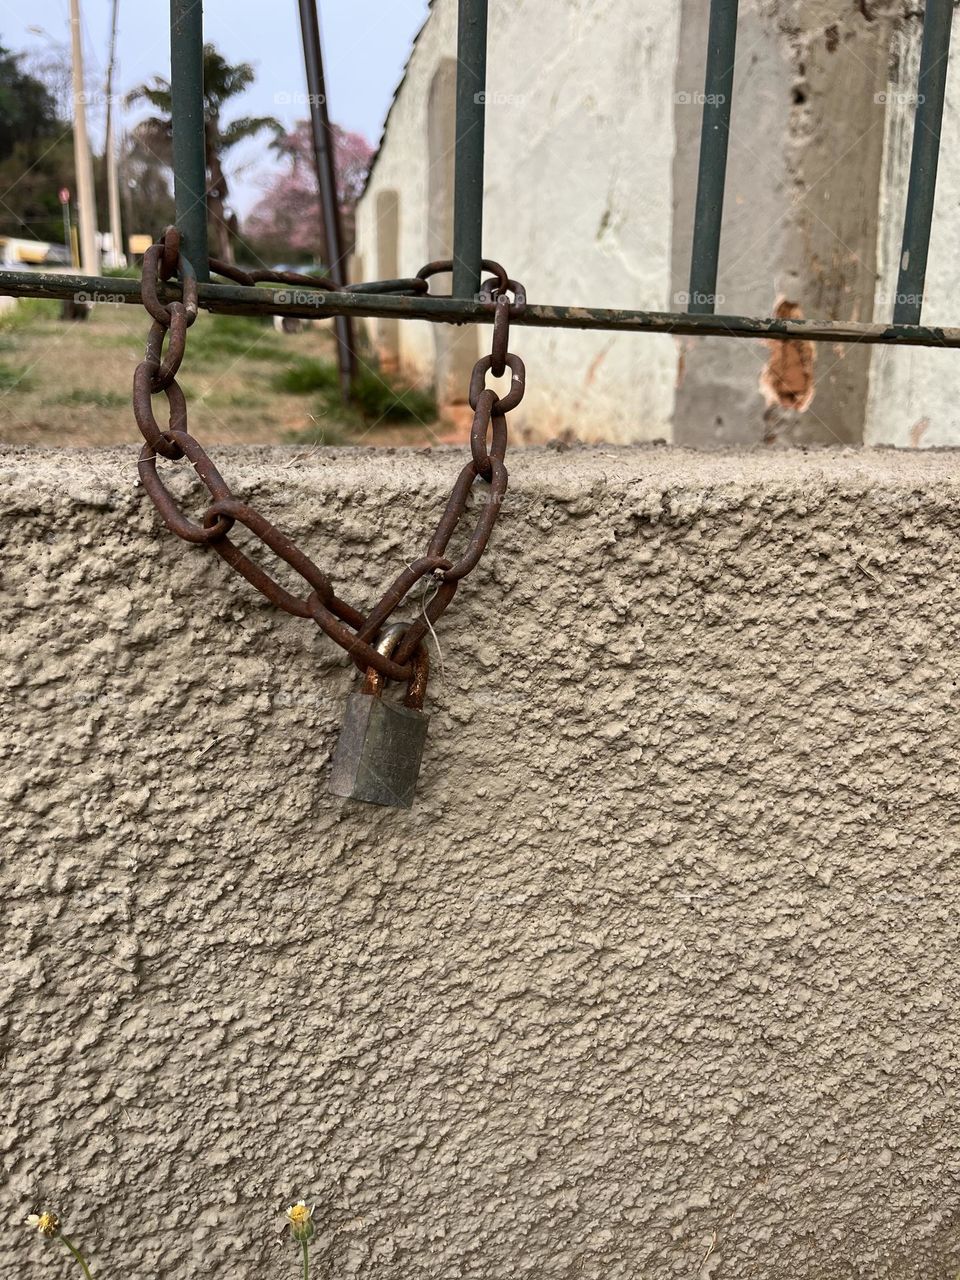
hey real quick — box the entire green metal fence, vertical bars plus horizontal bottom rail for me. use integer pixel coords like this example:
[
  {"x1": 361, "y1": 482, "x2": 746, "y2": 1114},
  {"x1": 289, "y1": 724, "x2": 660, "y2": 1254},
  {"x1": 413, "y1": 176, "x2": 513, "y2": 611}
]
[{"x1": 0, "y1": 0, "x2": 960, "y2": 347}]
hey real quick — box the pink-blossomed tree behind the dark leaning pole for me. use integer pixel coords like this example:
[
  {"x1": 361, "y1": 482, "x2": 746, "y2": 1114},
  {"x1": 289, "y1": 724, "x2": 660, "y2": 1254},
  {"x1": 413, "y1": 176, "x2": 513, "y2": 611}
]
[{"x1": 247, "y1": 120, "x2": 374, "y2": 262}]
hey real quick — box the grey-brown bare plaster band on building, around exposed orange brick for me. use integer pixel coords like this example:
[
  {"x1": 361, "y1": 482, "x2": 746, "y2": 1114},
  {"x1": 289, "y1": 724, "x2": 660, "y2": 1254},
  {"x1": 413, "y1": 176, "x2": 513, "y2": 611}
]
[{"x1": 673, "y1": 0, "x2": 904, "y2": 444}]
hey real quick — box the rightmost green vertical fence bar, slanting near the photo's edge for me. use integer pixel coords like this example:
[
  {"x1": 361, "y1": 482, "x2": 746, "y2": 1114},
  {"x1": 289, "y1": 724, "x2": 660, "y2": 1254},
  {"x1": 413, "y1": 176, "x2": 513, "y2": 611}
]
[{"x1": 893, "y1": 0, "x2": 954, "y2": 324}]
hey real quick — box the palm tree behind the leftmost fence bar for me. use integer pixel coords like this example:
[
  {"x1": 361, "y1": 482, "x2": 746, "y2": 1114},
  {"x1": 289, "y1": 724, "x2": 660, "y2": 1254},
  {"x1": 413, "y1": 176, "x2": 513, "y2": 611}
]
[{"x1": 128, "y1": 45, "x2": 283, "y2": 262}]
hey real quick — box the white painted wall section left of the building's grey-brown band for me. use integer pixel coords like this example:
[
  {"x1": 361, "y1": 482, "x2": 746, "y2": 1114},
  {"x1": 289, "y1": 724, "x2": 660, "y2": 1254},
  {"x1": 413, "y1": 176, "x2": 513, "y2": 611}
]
[{"x1": 357, "y1": 0, "x2": 680, "y2": 440}]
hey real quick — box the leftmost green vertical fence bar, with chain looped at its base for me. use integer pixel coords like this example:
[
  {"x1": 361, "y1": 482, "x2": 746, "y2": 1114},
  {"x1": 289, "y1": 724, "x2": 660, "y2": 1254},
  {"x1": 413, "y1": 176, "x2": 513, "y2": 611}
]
[{"x1": 170, "y1": 0, "x2": 210, "y2": 280}]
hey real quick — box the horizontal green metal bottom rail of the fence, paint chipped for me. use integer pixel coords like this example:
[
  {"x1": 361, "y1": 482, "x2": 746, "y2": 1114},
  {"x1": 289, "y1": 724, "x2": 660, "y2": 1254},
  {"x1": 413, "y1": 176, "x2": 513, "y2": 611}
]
[{"x1": 7, "y1": 271, "x2": 960, "y2": 347}]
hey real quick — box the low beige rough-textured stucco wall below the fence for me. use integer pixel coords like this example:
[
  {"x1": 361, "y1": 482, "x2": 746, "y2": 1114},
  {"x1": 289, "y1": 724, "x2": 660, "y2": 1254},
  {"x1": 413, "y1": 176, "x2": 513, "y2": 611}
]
[{"x1": 0, "y1": 448, "x2": 960, "y2": 1280}]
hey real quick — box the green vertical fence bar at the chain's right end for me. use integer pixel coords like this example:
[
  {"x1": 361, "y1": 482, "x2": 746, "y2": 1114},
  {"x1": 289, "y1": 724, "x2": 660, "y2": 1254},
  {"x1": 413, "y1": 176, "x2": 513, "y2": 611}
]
[{"x1": 453, "y1": 0, "x2": 486, "y2": 298}]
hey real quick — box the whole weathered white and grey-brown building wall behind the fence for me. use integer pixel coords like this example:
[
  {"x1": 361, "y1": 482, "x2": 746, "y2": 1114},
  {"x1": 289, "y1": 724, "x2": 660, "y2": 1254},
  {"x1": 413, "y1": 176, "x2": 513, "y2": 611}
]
[{"x1": 360, "y1": 0, "x2": 960, "y2": 447}]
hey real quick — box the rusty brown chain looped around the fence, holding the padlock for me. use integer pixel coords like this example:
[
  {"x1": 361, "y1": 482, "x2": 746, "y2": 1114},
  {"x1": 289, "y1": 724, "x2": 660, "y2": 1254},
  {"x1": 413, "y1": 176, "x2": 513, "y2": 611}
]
[{"x1": 133, "y1": 227, "x2": 526, "y2": 681}]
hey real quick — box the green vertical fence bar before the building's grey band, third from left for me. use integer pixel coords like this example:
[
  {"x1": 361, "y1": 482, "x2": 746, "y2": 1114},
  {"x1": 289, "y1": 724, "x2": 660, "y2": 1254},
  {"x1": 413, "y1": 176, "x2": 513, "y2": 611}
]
[{"x1": 687, "y1": 0, "x2": 737, "y2": 315}]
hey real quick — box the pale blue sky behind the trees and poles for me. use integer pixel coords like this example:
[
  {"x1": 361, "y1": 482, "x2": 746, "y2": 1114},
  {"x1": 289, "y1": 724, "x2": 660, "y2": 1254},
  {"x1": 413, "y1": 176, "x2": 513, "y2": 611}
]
[{"x1": 0, "y1": 0, "x2": 428, "y2": 216}]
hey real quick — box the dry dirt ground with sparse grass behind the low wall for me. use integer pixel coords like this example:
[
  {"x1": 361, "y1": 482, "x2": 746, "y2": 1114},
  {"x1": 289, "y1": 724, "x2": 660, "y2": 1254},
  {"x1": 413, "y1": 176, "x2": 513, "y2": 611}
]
[{"x1": 0, "y1": 301, "x2": 448, "y2": 447}]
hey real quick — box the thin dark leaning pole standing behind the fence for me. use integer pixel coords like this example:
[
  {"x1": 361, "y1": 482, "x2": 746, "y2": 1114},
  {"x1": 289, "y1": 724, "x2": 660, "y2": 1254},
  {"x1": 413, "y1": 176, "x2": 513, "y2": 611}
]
[{"x1": 300, "y1": 0, "x2": 357, "y2": 404}]
